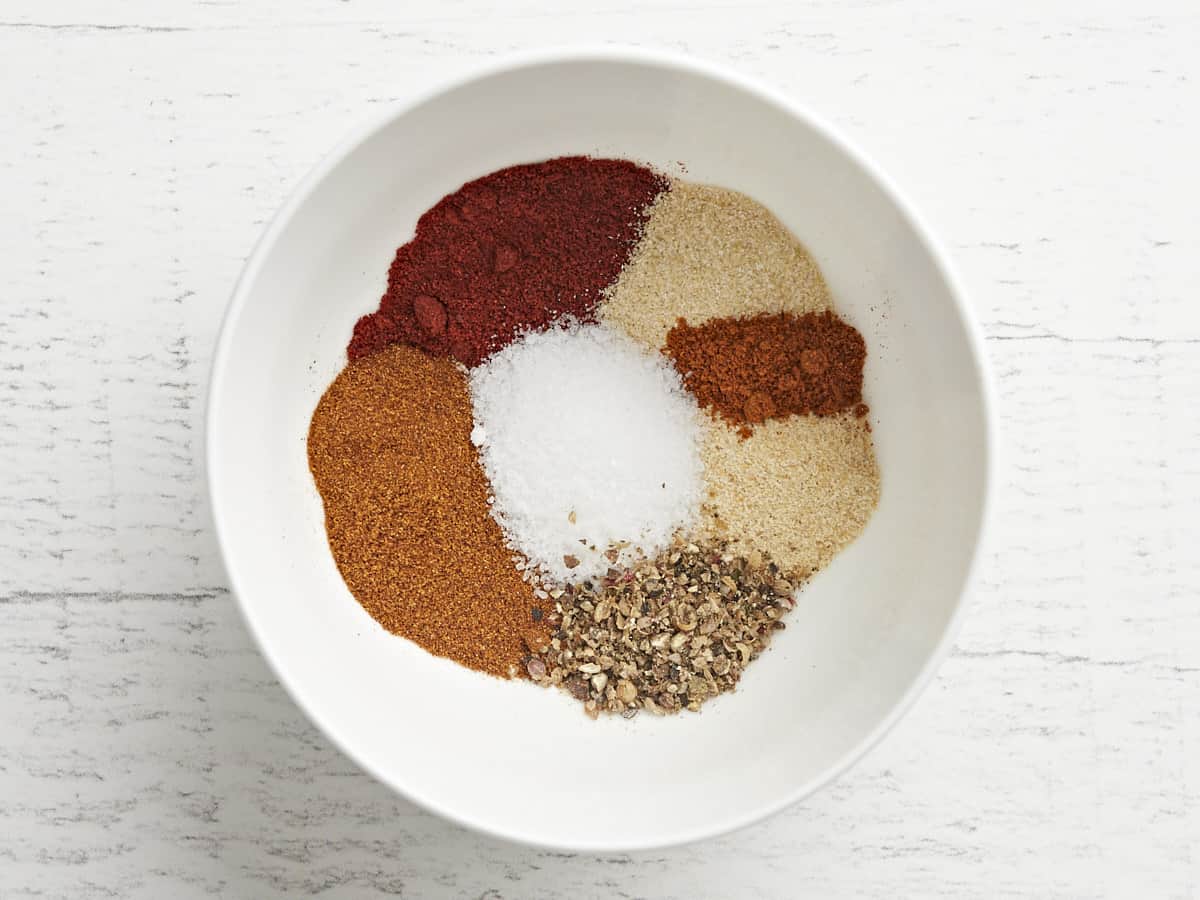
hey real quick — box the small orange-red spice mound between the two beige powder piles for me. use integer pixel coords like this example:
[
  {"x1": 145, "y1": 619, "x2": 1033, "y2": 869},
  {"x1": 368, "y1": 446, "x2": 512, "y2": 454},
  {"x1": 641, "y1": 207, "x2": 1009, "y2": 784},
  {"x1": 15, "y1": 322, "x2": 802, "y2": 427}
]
[{"x1": 666, "y1": 310, "x2": 868, "y2": 437}]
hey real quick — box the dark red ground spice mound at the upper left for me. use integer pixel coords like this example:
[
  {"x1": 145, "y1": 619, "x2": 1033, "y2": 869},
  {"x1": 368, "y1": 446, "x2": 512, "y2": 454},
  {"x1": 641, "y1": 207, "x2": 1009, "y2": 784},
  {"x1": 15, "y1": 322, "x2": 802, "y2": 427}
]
[{"x1": 347, "y1": 156, "x2": 667, "y2": 366}]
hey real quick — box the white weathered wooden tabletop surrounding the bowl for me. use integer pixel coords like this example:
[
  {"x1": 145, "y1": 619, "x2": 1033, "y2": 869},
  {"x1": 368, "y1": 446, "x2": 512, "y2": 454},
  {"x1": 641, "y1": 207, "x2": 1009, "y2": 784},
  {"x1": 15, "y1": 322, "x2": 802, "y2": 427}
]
[{"x1": 0, "y1": 0, "x2": 1200, "y2": 899}]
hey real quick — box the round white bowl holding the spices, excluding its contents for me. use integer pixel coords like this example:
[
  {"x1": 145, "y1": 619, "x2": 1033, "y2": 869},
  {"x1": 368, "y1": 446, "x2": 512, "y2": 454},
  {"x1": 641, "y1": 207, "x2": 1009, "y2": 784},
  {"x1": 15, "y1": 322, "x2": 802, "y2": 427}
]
[{"x1": 208, "y1": 49, "x2": 992, "y2": 851}]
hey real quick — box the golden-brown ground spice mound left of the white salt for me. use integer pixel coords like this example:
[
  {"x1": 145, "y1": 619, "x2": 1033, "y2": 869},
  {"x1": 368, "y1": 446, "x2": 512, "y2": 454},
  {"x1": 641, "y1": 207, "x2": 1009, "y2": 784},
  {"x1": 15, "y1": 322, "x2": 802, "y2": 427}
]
[{"x1": 308, "y1": 346, "x2": 550, "y2": 676}]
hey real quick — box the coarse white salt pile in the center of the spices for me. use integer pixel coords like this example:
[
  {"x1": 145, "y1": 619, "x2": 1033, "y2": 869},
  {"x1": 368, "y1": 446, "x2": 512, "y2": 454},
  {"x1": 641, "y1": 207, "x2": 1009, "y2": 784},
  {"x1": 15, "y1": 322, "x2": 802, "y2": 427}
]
[{"x1": 470, "y1": 325, "x2": 703, "y2": 581}]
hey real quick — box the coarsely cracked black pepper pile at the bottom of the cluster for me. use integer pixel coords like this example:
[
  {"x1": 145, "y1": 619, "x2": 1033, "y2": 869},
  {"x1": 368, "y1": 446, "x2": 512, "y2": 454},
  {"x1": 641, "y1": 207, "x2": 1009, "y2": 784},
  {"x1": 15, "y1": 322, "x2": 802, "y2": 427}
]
[{"x1": 527, "y1": 541, "x2": 794, "y2": 718}]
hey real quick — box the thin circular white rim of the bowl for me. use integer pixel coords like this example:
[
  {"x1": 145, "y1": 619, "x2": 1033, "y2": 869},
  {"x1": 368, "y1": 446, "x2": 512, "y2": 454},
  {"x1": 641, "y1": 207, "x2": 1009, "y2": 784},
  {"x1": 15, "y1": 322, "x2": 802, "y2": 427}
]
[{"x1": 204, "y1": 44, "x2": 997, "y2": 853}]
